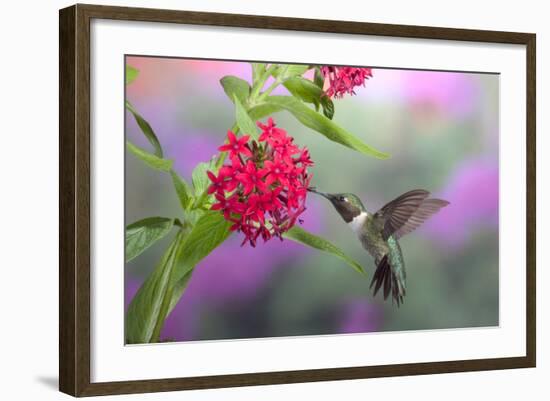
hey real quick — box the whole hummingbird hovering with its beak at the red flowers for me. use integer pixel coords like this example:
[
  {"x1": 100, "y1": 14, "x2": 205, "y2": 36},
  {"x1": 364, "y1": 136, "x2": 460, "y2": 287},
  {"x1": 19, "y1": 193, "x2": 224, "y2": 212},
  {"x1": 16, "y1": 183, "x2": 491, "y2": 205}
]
[{"x1": 308, "y1": 188, "x2": 449, "y2": 307}]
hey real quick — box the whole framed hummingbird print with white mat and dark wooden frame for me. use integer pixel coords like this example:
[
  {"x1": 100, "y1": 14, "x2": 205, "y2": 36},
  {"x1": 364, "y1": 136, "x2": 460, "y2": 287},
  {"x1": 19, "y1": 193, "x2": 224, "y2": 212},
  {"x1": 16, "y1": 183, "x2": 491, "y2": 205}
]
[{"x1": 59, "y1": 5, "x2": 536, "y2": 396}]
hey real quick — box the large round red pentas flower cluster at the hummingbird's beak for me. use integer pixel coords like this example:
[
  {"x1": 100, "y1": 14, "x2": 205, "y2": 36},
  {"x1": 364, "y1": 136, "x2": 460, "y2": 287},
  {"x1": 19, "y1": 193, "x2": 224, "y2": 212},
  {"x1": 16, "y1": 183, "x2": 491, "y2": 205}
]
[{"x1": 208, "y1": 118, "x2": 313, "y2": 246}]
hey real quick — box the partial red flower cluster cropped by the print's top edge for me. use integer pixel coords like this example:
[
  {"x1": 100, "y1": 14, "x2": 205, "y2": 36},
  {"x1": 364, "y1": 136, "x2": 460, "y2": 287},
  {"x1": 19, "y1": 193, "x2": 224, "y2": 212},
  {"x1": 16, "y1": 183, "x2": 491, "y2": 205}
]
[{"x1": 321, "y1": 66, "x2": 372, "y2": 98}]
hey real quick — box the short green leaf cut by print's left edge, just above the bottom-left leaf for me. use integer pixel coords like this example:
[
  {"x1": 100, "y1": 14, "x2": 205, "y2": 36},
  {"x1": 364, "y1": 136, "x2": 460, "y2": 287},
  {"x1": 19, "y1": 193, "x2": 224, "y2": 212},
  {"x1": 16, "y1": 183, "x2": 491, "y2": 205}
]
[{"x1": 126, "y1": 217, "x2": 174, "y2": 262}]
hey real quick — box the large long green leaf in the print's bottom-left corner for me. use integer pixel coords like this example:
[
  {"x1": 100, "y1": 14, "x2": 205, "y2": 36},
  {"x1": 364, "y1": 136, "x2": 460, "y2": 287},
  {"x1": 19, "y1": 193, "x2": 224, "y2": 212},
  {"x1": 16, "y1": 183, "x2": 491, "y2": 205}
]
[{"x1": 125, "y1": 231, "x2": 184, "y2": 344}]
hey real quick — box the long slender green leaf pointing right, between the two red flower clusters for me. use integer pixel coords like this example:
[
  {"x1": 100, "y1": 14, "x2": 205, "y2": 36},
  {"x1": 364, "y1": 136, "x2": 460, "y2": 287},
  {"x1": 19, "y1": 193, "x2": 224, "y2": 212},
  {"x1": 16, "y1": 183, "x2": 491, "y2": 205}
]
[{"x1": 266, "y1": 96, "x2": 389, "y2": 159}]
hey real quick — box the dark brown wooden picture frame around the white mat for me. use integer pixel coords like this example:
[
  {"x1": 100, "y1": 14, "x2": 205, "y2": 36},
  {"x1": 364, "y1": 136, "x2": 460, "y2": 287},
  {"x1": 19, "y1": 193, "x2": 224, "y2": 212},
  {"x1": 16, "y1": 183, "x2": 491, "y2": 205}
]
[{"x1": 59, "y1": 5, "x2": 536, "y2": 396}]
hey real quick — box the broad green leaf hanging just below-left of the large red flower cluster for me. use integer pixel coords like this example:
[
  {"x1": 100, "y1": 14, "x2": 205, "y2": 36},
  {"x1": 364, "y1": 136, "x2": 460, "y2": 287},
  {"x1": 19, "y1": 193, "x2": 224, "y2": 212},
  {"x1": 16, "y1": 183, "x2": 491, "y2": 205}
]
[{"x1": 172, "y1": 210, "x2": 231, "y2": 285}]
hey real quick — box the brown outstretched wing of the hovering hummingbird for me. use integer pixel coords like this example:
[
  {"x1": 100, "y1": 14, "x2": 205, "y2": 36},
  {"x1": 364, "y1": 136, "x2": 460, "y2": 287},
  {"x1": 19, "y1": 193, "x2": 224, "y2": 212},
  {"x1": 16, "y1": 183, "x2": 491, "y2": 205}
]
[{"x1": 374, "y1": 189, "x2": 449, "y2": 240}]
